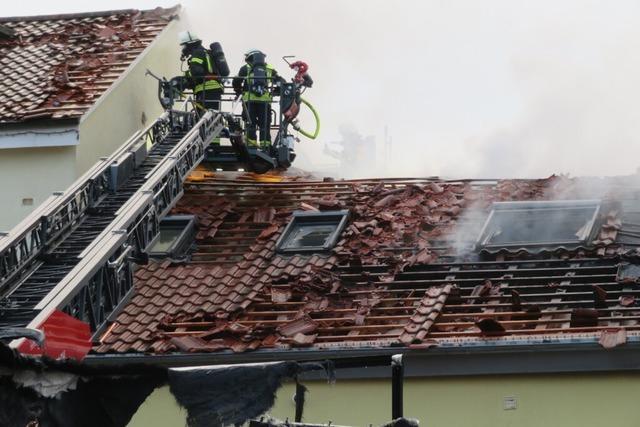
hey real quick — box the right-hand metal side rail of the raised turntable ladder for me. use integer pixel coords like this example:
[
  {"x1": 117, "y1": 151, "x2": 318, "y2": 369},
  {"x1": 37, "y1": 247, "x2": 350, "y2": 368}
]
[{"x1": 28, "y1": 111, "x2": 223, "y2": 335}]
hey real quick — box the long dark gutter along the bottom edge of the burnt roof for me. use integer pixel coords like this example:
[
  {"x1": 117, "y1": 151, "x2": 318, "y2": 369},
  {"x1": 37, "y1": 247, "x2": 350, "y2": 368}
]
[{"x1": 84, "y1": 337, "x2": 640, "y2": 379}]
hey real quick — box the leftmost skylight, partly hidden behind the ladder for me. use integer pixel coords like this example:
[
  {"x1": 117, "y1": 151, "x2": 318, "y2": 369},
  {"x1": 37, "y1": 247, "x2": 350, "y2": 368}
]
[{"x1": 149, "y1": 215, "x2": 195, "y2": 258}]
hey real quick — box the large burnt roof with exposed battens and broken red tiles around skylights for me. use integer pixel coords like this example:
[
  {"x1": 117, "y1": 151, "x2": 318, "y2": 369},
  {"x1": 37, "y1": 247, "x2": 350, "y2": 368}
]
[{"x1": 94, "y1": 173, "x2": 640, "y2": 354}]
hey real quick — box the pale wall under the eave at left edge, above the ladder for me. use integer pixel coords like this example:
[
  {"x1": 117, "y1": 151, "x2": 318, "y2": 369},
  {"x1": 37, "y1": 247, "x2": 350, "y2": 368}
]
[{"x1": 0, "y1": 146, "x2": 76, "y2": 231}]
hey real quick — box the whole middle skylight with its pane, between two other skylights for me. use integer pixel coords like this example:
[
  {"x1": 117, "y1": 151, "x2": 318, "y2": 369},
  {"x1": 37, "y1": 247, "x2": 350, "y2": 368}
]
[{"x1": 276, "y1": 210, "x2": 349, "y2": 253}]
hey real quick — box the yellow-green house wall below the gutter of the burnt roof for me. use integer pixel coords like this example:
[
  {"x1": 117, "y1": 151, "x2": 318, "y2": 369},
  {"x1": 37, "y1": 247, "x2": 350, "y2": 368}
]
[{"x1": 129, "y1": 373, "x2": 640, "y2": 427}]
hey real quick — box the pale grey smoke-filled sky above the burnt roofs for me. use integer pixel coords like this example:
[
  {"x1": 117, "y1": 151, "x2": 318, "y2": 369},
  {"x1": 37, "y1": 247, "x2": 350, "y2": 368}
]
[{"x1": 3, "y1": 0, "x2": 640, "y2": 177}]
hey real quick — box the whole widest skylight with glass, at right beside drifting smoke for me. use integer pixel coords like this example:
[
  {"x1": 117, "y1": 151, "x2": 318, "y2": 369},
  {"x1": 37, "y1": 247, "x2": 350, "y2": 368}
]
[{"x1": 477, "y1": 200, "x2": 600, "y2": 249}]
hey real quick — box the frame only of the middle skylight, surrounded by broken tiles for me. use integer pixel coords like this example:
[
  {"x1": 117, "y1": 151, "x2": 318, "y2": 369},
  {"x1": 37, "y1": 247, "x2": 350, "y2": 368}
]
[{"x1": 276, "y1": 209, "x2": 349, "y2": 254}]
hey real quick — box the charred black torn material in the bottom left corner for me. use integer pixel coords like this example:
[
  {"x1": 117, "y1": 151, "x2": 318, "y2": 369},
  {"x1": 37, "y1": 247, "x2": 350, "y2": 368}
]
[{"x1": 0, "y1": 342, "x2": 167, "y2": 427}]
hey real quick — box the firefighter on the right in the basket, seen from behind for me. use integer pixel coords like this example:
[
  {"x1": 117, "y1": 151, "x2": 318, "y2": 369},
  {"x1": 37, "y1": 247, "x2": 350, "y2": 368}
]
[{"x1": 232, "y1": 49, "x2": 282, "y2": 148}]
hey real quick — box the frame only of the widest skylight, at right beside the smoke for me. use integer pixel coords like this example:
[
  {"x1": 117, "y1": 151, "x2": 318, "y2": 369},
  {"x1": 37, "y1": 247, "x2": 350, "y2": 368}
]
[{"x1": 475, "y1": 199, "x2": 602, "y2": 250}]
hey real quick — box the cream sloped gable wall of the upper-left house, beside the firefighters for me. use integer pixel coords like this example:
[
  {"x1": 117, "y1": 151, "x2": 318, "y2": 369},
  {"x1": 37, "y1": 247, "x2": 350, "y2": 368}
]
[{"x1": 76, "y1": 20, "x2": 181, "y2": 176}]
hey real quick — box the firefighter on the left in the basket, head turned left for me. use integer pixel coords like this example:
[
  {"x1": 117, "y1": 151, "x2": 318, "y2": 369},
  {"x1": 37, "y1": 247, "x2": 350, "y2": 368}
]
[{"x1": 178, "y1": 31, "x2": 229, "y2": 112}]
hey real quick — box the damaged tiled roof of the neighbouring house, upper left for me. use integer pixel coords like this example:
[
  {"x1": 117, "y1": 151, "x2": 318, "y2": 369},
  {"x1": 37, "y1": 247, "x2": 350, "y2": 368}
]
[{"x1": 0, "y1": 6, "x2": 179, "y2": 123}]
